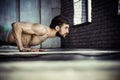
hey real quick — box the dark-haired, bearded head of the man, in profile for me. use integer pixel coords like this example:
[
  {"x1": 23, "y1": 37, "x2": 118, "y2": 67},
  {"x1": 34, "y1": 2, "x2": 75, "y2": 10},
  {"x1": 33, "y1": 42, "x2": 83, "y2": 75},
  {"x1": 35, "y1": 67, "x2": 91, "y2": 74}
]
[{"x1": 50, "y1": 15, "x2": 69, "y2": 38}]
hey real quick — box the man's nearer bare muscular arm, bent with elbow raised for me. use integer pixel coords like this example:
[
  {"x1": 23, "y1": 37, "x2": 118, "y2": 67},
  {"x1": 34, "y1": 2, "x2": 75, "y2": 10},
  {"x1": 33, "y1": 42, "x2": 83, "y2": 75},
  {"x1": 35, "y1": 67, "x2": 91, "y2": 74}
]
[{"x1": 12, "y1": 22, "x2": 46, "y2": 51}]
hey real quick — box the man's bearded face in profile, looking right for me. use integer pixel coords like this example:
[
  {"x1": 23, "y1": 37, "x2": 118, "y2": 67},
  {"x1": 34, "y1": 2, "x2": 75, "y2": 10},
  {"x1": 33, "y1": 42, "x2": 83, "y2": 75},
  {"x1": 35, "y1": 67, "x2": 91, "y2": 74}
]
[{"x1": 56, "y1": 24, "x2": 69, "y2": 38}]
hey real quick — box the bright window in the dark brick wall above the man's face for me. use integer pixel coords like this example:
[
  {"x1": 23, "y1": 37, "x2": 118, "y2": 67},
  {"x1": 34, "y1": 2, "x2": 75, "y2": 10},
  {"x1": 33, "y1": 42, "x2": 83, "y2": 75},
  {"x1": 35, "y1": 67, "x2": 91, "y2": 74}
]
[{"x1": 73, "y1": 0, "x2": 92, "y2": 25}]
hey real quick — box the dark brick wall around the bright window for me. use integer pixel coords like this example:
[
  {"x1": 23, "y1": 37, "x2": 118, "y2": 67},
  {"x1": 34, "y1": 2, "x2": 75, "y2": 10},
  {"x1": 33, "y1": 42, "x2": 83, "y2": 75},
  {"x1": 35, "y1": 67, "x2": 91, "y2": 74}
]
[{"x1": 61, "y1": 0, "x2": 120, "y2": 49}]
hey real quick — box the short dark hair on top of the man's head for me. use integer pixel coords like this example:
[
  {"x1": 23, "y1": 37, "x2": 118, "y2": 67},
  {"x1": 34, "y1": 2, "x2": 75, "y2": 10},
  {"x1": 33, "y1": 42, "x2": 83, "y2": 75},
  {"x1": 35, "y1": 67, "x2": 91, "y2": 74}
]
[{"x1": 50, "y1": 15, "x2": 69, "y2": 29}]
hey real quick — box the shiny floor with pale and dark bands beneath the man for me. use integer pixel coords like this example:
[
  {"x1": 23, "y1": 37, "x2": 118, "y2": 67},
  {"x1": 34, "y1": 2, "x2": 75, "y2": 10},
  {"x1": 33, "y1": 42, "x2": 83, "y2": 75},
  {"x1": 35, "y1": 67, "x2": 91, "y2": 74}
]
[{"x1": 0, "y1": 49, "x2": 120, "y2": 80}]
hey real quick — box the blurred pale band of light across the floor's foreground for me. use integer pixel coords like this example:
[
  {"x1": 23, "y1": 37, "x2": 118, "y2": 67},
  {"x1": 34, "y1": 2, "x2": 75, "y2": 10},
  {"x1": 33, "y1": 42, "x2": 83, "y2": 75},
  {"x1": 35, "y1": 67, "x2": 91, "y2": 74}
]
[{"x1": 0, "y1": 60, "x2": 120, "y2": 80}]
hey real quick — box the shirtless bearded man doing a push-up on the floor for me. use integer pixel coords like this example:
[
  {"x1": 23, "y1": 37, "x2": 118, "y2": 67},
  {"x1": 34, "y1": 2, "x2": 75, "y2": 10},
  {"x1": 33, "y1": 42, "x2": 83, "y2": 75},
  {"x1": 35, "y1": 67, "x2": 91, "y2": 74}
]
[{"x1": 0, "y1": 15, "x2": 69, "y2": 52}]
